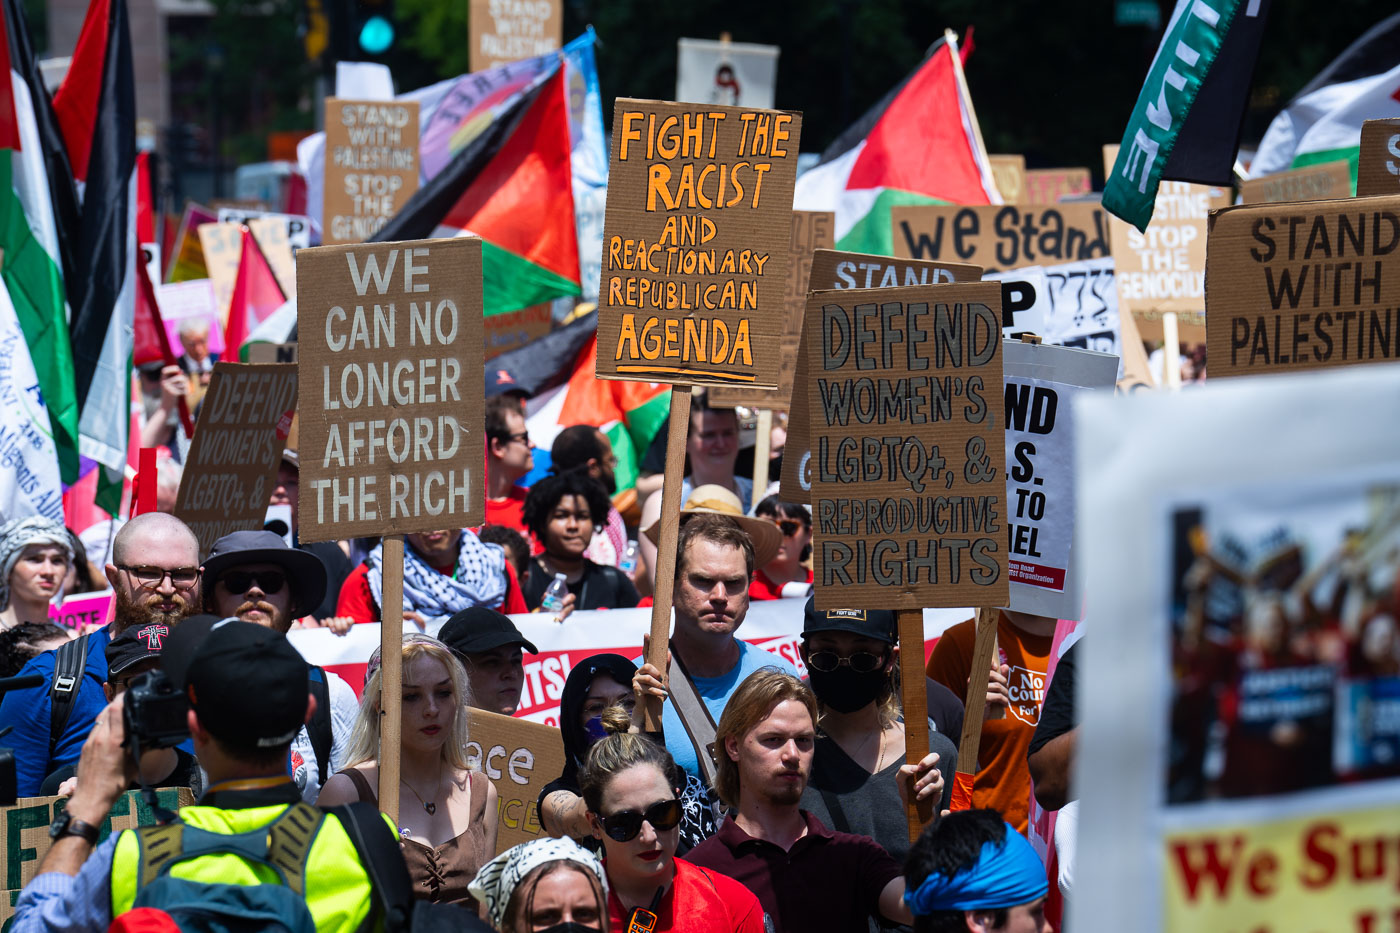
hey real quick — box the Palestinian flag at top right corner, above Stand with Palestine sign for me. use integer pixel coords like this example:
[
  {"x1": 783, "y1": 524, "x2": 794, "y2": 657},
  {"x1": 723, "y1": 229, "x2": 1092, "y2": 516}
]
[{"x1": 1249, "y1": 13, "x2": 1400, "y2": 183}]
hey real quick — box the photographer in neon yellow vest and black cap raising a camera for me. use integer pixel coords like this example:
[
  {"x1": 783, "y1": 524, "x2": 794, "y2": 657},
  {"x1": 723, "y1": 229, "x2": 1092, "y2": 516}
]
[{"x1": 13, "y1": 616, "x2": 406, "y2": 933}]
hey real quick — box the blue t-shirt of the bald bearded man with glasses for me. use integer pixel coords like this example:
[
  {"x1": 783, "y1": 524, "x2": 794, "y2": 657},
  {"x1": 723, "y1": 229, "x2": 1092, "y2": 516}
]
[{"x1": 0, "y1": 626, "x2": 112, "y2": 797}]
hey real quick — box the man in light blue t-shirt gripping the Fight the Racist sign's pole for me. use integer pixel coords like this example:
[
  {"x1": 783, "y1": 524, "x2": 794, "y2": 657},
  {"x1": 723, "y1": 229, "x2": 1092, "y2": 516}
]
[{"x1": 637, "y1": 513, "x2": 797, "y2": 779}]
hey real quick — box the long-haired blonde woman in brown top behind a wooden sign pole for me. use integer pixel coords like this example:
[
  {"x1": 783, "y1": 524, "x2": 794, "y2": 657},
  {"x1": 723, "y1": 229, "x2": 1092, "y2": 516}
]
[{"x1": 316, "y1": 635, "x2": 497, "y2": 912}]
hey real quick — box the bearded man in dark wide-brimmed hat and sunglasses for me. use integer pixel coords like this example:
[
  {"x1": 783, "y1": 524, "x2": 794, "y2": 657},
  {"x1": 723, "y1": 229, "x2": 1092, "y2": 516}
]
[{"x1": 204, "y1": 531, "x2": 360, "y2": 804}]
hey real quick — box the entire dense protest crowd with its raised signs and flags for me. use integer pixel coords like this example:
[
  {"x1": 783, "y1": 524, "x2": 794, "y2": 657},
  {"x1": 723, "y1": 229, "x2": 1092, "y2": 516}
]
[{"x1": 0, "y1": 0, "x2": 1400, "y2": 933}]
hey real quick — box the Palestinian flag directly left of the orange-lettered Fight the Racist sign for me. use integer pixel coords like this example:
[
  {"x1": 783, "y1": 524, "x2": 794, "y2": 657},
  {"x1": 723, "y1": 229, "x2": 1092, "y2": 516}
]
[{"x1": 374, "y1": 69, "x2": 580, "y2": 315}]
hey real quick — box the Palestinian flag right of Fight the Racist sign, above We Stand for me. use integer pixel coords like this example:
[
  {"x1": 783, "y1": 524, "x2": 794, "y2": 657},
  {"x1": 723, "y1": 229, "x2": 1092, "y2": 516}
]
[{"x1": 792, "y1": 32, "x2": 1001, "y2": 256}]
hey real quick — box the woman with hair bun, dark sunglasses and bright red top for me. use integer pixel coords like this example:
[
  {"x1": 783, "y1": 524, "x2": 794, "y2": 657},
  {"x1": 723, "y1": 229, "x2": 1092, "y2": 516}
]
[{"x1": 580, "y1": 714, "x2": 764, "y2": 933}]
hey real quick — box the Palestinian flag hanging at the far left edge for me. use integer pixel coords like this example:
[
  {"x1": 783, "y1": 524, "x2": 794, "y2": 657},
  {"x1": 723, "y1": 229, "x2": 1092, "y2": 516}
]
[{"x1": 0, "y1": 0, "x2": 78, "y2": 483}]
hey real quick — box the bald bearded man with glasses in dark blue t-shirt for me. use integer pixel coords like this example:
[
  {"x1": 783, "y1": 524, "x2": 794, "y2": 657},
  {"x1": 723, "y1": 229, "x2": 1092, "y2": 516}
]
[{"x1": 0, "y1": 511, "x2": 200, "y2": 797}]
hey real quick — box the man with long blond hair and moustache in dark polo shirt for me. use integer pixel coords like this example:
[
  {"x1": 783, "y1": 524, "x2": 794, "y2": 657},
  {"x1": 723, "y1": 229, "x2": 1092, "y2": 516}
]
[{"x1": 686, "y1": 668, "x2": 942, "y2": 933}]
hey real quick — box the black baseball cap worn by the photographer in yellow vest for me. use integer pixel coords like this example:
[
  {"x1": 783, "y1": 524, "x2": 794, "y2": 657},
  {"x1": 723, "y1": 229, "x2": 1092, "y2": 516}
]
[{"x1": 161, "y1": 615, "x2": 311, "y2": 748}]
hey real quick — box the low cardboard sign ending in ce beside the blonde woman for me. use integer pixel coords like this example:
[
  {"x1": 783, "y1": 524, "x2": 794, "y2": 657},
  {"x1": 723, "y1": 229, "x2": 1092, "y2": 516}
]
[{"x1": 466, "y1": 707, "x2": 564, "y2": 855}]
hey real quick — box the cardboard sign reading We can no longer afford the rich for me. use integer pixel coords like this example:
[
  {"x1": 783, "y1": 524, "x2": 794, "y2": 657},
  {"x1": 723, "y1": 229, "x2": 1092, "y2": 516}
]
[{"x1": 297, "y1": 237, "x2": 486, "y2": 541}]
